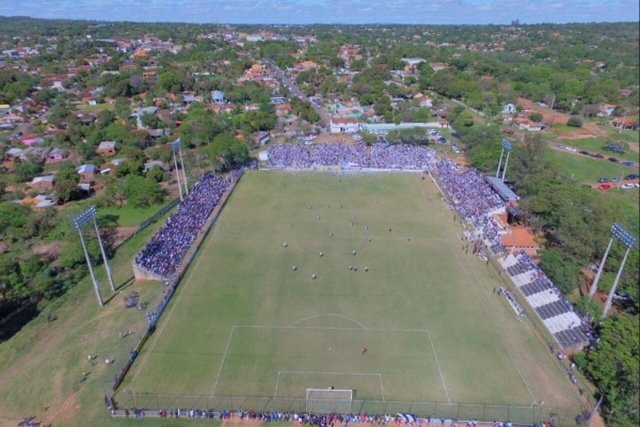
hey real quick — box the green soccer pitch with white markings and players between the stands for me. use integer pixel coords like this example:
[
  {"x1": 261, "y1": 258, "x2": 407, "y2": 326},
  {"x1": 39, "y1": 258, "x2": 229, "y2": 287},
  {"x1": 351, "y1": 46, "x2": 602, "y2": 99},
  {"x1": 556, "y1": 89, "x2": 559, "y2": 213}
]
[{"x1": 117, "y1": 171, "x2": 580, "y2": 420}]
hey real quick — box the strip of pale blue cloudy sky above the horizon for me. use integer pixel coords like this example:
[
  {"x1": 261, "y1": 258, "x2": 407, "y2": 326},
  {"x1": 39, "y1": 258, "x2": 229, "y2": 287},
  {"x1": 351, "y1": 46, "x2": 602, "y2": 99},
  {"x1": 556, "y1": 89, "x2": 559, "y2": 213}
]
[{"x1": 0, "y1": 0, "x2": 640, "y2": 25}]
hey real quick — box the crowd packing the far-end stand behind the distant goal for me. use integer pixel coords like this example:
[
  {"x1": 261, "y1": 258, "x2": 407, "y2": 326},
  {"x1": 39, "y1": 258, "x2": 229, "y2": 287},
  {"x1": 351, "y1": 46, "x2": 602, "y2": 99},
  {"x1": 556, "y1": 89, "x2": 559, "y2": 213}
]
[{"x1": 268, "y1": 143, "x2": 435, "y2": 170}]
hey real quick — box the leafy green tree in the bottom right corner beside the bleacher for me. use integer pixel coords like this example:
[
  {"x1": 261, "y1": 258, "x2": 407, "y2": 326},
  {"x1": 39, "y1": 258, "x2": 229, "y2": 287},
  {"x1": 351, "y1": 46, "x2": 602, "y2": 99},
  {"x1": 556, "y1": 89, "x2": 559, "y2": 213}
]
[{"x1": 586, "y1": 316, "x2": 640, "y2": 426}]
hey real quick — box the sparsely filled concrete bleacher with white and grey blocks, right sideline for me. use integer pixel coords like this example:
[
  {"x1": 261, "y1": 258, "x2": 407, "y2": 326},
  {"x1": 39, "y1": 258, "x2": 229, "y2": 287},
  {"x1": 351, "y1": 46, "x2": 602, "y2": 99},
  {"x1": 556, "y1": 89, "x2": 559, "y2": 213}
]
[{"x1": 498, "y1": 254, "x2": 589, "y2": 348}]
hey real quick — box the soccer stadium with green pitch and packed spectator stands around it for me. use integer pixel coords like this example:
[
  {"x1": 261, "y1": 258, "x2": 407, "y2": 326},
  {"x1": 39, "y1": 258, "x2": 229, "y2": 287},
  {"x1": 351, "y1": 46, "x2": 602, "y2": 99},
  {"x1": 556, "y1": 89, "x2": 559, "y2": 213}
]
[{"x1": 115, "y1": 144, "x2": 588, "y2": 423}]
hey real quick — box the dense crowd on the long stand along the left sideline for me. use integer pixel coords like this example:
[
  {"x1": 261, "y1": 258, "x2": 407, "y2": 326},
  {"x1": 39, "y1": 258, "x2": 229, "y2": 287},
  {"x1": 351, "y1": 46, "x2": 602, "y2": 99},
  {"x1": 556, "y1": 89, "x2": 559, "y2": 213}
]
[{"x1": 135, "y1": 172, "x2": 229, "y2": 278}]
